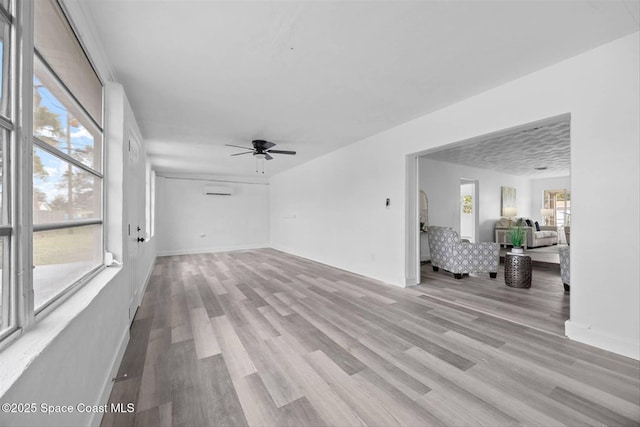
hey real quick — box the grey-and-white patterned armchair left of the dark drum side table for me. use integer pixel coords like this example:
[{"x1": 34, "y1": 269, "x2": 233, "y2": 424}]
[{"x1": 427, "y1": 225, "x2": 500, "y2": 279}]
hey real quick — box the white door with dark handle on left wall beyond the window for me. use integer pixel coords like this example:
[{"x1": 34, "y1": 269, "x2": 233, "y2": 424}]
[{"x1": 127, "y1": 138, "x2": 145, "y2": 321}]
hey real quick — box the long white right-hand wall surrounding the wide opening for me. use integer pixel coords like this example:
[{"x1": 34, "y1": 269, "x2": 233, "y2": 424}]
[{"x1": 271, "y1": 33, "x2": 640, "y2": 358}]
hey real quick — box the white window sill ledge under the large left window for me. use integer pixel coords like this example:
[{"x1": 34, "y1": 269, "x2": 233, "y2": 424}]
[{"x1": 0, "y1": 267, "x2": 122, "y2": 397}]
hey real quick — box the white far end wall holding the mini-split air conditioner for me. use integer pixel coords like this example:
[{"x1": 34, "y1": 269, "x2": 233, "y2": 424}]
[{"x1": 156, "y1": 177, "x2": 270, "y2": 255}]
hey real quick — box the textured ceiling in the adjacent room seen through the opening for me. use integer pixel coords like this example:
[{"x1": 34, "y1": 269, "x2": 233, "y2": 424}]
[{"x1": 423, "y1": 119, "x2": 571, "y2": 178}]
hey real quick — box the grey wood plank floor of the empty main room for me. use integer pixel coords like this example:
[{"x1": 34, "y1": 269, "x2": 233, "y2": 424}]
[{"x1": 102, "y1": 249, "x2": 640, "y2": 426}]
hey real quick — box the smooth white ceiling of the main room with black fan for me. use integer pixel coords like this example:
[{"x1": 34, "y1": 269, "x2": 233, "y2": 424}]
[{"x1": 75, "y1": 0, "x2": 640, "y2": 176}]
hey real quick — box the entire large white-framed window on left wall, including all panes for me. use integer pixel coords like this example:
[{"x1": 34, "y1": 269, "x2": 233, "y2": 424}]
[{"x1": 0, "y1": 0, "x2": 104, "y2": 343}]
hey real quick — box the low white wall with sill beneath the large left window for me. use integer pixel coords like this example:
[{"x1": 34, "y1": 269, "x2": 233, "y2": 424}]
[{"x1": 0, "y1": 269, "x2": 129, "y2": 426}]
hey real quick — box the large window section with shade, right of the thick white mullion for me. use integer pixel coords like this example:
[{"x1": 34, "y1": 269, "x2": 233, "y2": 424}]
[{"x1": 33, "y1": 0, "x2": 104, "y2": 313}]
